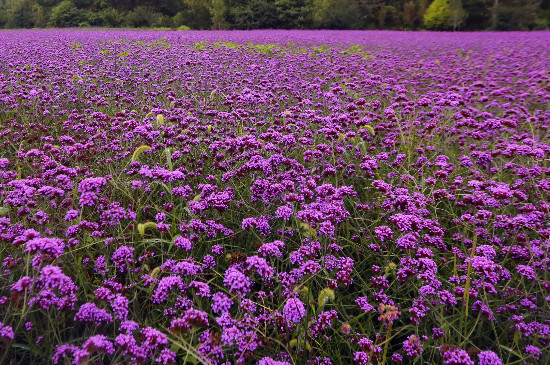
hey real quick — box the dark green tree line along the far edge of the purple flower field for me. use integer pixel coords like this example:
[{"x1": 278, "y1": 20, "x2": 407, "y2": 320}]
[{"x1": 0, "y1": 0, "x2": 550, "y2": 30}]
